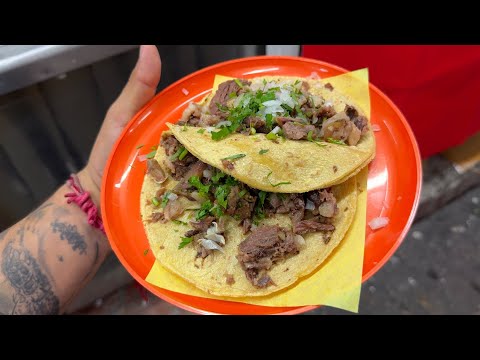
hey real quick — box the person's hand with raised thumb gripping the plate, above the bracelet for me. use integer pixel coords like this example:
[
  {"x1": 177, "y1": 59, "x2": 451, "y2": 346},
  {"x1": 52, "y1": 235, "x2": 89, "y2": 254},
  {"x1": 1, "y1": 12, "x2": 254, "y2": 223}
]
[{"x1": 78, "y1": 45, "x2": 162, "y2": 206}]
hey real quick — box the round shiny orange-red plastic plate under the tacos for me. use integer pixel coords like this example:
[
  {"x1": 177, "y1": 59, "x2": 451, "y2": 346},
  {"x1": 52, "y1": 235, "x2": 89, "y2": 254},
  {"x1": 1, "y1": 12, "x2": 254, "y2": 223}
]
[{"x1": 101, "y1": 56, "x2": 422, "y2": 314}]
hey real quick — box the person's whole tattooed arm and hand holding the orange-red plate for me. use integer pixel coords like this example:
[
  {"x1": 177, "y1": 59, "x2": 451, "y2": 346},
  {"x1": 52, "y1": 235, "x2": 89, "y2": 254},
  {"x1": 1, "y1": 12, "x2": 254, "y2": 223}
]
[{"x1": 0, "y1": 45, "x2": 161, "y2": 314}]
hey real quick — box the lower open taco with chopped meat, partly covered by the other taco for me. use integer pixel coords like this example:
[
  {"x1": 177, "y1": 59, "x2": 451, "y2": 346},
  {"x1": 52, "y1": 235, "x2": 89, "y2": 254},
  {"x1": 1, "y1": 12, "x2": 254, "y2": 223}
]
[{"x1": 140, "y1": 132, "x2": 357, "y2": 297}]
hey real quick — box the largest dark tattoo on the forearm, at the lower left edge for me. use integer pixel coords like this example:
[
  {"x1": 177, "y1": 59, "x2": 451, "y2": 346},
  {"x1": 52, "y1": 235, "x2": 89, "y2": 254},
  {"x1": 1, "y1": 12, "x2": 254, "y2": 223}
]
[{"x1": 2, "y1": 241, "x2": 60, "y2": 314}]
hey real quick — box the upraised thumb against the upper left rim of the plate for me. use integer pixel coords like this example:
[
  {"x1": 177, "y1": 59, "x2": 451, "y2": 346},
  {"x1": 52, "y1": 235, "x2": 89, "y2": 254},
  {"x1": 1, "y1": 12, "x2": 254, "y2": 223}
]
[{"x1": 105, "y1": 45, "x2": 162, "y2": 127}]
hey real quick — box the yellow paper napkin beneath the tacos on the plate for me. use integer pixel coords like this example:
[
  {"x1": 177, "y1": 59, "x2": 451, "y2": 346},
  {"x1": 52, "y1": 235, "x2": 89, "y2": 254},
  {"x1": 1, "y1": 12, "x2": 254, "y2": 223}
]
[{"x1": 145, "y1": 69, "x2": 370, "y2": 312}]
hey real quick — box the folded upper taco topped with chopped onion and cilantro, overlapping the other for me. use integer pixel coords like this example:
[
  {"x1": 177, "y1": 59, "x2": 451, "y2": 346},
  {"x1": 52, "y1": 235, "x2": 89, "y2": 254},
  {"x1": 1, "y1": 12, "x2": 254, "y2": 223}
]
[{"x1": 168, "y1": 77, "x2": 375, "y2": 193}]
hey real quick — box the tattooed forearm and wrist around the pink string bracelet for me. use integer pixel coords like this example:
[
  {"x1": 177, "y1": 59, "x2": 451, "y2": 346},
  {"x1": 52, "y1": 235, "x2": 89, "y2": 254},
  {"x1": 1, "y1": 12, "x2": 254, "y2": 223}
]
[{"x1": 0, "y1": 170, "x2": 105, "y2": 314}]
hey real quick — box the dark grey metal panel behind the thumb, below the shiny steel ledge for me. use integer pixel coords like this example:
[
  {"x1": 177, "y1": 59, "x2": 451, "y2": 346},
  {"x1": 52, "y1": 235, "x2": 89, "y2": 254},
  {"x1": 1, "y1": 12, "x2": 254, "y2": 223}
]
[{"x1": 0, "y1": 45, "x2": 265, "y2": 231}]
